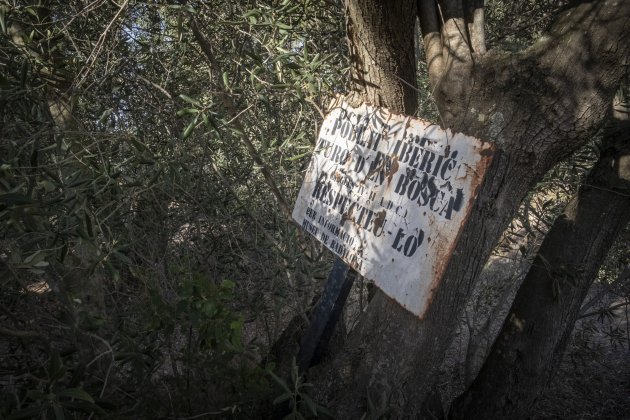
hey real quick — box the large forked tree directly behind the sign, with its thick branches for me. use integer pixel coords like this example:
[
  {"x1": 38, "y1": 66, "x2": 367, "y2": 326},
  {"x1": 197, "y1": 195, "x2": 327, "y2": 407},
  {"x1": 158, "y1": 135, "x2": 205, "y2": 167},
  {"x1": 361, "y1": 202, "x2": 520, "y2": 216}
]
[{"x1": 310, "y1": 0, "x2": 630, "y2": 418}]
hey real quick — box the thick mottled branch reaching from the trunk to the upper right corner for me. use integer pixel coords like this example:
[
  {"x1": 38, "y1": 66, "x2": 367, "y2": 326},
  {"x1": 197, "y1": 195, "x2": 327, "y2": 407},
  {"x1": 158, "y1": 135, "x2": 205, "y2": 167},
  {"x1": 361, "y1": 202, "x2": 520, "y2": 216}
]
[{"x1": 464, "y1": 0, "x2": 630, "y2": 143}]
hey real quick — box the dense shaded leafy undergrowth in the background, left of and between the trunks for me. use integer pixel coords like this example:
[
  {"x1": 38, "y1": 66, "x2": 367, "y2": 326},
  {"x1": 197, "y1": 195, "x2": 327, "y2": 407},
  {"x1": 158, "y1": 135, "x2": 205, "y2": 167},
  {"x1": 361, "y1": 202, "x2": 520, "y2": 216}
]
[{"x1": 0, "y1": 0, "x2": 630, "y2": 418}]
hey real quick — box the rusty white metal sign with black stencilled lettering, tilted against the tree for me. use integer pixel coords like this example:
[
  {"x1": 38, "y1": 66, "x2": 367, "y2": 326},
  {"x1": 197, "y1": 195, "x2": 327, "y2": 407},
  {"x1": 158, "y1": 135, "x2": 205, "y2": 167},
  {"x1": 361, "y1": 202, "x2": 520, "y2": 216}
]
[{"x1": 293, "y1": 100, "x2": 492, "y2": 316}]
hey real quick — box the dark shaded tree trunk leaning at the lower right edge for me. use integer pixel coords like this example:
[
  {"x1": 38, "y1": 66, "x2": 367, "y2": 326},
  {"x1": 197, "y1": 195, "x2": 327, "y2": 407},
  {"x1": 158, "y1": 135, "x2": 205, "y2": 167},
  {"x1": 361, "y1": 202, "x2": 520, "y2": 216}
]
[{"x1": 450, "y1": 85, "x2": 630, "y2": 419}]
